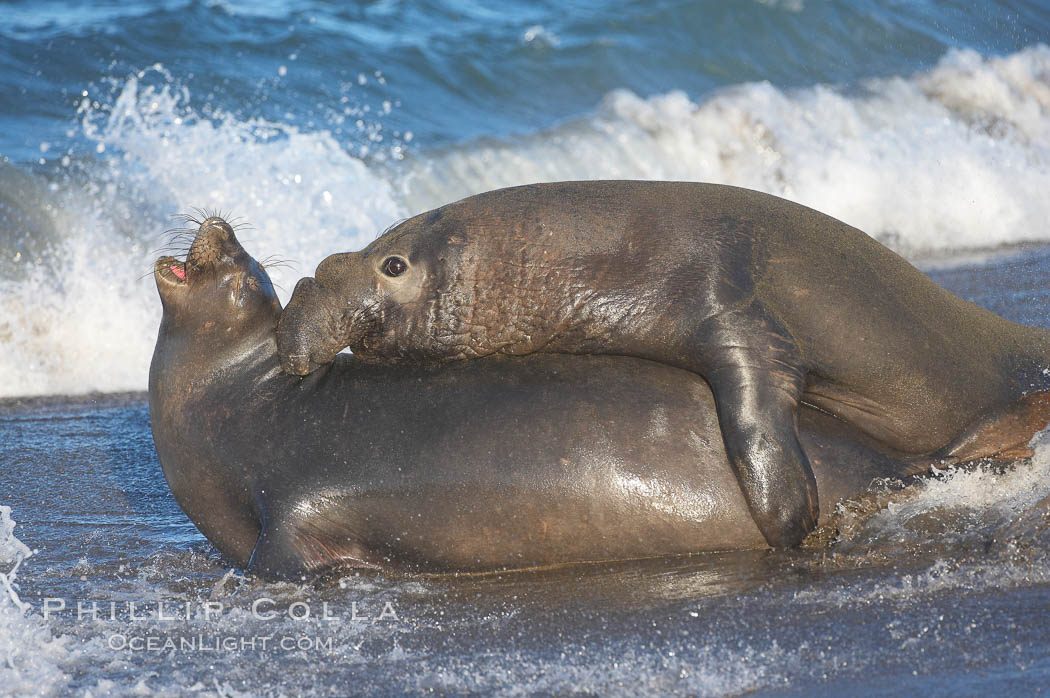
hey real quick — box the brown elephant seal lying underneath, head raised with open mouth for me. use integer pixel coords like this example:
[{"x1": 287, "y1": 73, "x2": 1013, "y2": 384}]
[{"x1": 149, "y1": 218, "x2": 923, "y2": 579}]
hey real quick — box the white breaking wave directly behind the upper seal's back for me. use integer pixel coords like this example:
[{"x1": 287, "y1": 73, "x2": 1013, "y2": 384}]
[{"x1": 398, "y1": 46, "x2": 1050, "y2": 251}]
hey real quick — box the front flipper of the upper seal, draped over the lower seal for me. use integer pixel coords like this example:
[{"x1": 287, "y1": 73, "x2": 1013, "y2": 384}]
[{"x1": 701, "y1": 309, "x2": 819, "y2": 548}]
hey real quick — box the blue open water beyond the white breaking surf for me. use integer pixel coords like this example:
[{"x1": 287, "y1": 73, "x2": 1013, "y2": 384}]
[{"x1": 6, "y1": 0, "x2": 1050, "y2": 163}]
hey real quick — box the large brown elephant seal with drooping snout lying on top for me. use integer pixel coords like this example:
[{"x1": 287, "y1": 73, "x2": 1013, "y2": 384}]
[{"x1": 278, "y1": 182, "x2": 1050, "y2": 546}]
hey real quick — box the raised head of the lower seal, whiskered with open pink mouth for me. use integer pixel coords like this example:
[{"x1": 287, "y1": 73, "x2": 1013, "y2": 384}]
[{"x1": 153, "y1": 216, "x2": 280, "y2": 339}]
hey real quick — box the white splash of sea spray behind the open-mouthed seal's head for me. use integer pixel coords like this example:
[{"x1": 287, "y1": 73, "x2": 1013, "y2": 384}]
[{"x1": 0, "y1": 66, "x2": 401, "y2": 397}]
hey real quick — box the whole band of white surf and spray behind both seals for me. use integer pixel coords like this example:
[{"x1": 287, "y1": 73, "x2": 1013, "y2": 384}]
[{"x1": 0, "y1": 46, "x2": 1050, "y2": 397}]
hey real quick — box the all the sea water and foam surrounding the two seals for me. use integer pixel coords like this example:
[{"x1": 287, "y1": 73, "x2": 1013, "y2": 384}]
[{"x1": 0, "y1": 0, "x2": 1050, "y2": 696}]
